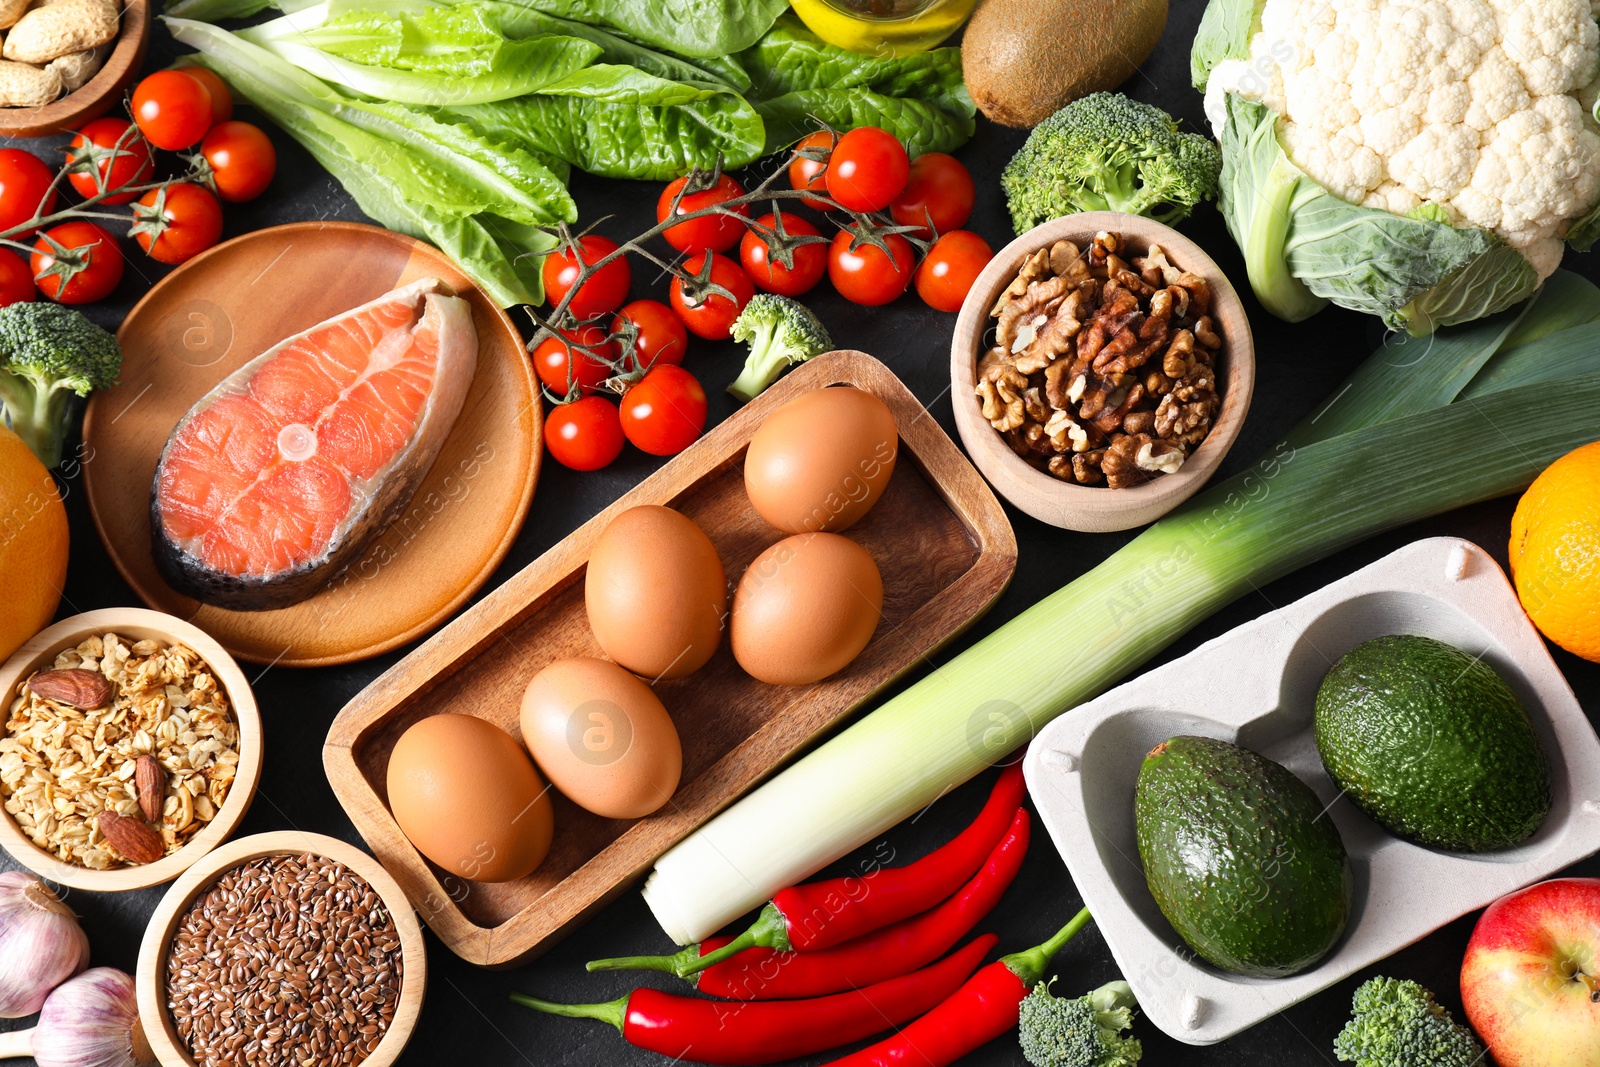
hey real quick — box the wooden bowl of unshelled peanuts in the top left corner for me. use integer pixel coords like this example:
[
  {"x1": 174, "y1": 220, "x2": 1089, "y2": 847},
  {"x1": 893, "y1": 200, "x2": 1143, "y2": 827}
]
[{"x1": 0, "y1": 0, "x2": 150, "y2": 138}]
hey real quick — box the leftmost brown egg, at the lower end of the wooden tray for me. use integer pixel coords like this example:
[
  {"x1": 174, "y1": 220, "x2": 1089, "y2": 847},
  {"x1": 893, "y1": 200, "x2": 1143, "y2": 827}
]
[{"x1": 389, "y1": 715, "x2": 555, "y2": 881}]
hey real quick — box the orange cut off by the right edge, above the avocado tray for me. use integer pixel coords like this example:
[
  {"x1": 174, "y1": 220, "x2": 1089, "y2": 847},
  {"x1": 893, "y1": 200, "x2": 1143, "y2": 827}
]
[{"x1": 1510, "y1": 442, "x2": 1600, "y2": 662}]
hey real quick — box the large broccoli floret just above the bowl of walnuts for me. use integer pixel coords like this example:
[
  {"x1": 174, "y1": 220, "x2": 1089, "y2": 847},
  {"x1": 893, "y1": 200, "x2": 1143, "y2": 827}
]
[{"x1": 1000, "y1": 93, "x2": 1222, "y2": 234}]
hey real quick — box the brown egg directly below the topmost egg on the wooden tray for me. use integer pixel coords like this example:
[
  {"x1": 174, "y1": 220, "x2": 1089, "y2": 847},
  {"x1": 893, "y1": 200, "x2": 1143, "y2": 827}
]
[{"x1": 731, "y1": 533, "x2": 883, "y2": 685}]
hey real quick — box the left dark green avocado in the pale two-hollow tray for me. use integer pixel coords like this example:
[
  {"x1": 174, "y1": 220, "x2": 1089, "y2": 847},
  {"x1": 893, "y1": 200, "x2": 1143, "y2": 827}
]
[{"x1": 1133, "y1": 737, "x2": 1350, "y2": 977}]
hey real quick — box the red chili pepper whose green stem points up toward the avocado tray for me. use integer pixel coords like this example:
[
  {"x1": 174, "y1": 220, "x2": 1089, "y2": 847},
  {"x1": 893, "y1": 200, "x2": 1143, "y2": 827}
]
[{"x1": 826, "y1": 909, "x2": 1090, "y2": 1067}]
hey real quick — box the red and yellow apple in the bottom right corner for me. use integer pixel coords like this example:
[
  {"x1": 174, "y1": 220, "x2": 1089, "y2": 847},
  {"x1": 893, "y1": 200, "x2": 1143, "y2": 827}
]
[{"x1": 1461, "y1": 878, "x2": 1600, "y2": 1067}]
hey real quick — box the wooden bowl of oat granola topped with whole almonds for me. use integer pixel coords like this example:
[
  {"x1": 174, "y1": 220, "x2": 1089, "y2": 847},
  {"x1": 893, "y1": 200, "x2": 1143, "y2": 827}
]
[{"x1": 0, "y1": 608, "x2": 261, "y2": 893}]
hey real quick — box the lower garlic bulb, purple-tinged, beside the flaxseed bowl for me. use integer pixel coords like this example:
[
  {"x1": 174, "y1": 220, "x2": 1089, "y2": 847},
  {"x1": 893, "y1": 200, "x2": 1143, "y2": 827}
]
[{"x1": 32, "y1": 966, "x2": 155, "y2": 1067}]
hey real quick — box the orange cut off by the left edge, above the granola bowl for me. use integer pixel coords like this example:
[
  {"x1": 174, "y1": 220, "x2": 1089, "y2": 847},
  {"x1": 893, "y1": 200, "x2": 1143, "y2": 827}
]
[{"x1": 0, "y1": 426, "x2": 67, "y2": 659}]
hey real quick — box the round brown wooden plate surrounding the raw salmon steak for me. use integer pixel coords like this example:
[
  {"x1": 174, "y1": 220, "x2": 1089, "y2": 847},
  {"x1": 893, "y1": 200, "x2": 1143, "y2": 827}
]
[{"x1": 82, "y1": 222, "x2": 542, "y2": 667}]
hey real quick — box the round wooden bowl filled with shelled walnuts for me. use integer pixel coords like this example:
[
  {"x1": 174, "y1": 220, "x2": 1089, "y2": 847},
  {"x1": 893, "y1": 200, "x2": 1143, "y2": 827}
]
[{"x1": 950, "y1": 211, "x2": 1256, "y2": 533}]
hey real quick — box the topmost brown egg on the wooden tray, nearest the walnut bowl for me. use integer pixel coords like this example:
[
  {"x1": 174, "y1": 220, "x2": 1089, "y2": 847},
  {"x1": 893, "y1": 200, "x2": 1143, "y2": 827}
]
[{"x1": 744, "y1": 386, "x2": 899, "y2": 533}]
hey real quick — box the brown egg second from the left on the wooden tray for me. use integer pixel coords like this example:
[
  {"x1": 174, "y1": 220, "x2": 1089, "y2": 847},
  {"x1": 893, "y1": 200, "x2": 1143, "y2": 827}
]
[{"x1": 522, "y1": 656, "x2": 683, "y2": 819}]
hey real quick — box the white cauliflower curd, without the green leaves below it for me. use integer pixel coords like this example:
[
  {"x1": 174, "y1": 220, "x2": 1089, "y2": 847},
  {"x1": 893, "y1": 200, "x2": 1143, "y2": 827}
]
[{"x1": 1206, "y1": 0, "x2": 1600, "y2": 278}]
